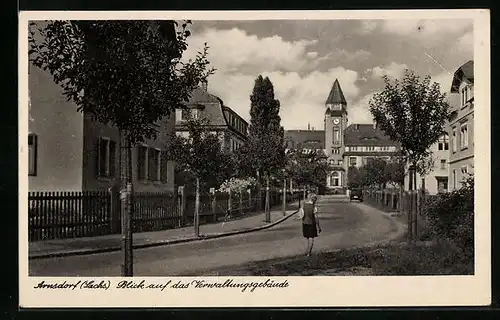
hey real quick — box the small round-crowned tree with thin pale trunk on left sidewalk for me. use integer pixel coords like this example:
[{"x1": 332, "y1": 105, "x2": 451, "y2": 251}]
[{"x1": 165, "y1": 119, "x2": 232, "y2": 237}]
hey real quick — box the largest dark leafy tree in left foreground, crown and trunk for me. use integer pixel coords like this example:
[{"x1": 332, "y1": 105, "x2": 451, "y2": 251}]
[{"x1": 29, "y1": 20, "x2": 213, "y2": 276}]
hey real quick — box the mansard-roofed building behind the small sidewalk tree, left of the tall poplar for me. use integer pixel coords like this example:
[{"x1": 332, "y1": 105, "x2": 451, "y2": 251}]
[{"x1": 175, "y1": 82, "x2": 248, "y2": 153}]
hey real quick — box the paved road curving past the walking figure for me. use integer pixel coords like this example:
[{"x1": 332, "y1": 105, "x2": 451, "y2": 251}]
[{"x1": 29, "y1": 197, "x2": 398, "y2": 276}]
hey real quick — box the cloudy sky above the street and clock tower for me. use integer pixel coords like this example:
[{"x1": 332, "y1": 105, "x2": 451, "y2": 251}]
[{"x1": 184, "y1": 19, "x2": 474, "y2": 130}]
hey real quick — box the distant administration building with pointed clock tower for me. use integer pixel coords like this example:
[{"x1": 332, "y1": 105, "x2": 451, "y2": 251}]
[{"x1": 285, "y1": 80, "x2": 399, "y2": 193}]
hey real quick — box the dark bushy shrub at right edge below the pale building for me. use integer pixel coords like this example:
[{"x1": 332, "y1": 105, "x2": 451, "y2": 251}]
[{"x1": 423, "y1": 177, "x2": 474, "y2": 250}]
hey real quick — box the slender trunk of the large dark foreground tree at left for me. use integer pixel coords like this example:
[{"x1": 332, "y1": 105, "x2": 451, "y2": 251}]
[{"x1": 119, "y1": 130, "x2": 134, "y2": 277}]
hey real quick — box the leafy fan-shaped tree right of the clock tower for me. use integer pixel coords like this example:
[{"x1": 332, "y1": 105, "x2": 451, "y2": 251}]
[{"x1": 369, "y1": 70, "x2": 449, "y2": 190}]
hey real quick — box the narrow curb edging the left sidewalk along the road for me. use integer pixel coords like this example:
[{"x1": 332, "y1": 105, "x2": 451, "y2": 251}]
[{"x1": 28, "y1": 210, "x2": 299, "y2": 260}]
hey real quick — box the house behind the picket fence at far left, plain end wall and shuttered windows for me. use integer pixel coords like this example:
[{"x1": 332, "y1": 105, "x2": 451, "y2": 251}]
[{"x1": 28, "y1": 65, "x2": 175, "y2": 192}]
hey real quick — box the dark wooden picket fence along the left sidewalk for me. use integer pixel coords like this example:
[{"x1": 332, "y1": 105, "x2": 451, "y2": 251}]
[{"x1": 28, "y1": 190, "x2": 301, "y2": 241}]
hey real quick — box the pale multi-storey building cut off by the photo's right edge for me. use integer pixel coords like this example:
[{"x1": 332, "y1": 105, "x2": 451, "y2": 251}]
[{"x1": 448, "y1": 61, "x2": 474, "y2": 190}]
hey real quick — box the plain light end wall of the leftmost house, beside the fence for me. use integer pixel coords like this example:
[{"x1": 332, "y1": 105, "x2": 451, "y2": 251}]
[{"x1": 28, "y1": 64, "x2": 84, "y2": 191}]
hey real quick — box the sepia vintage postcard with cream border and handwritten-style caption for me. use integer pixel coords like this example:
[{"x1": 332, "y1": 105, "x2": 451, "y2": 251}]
[{"x1": 19, "y1": 9, "x2": 491, "y2": 308}]
